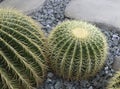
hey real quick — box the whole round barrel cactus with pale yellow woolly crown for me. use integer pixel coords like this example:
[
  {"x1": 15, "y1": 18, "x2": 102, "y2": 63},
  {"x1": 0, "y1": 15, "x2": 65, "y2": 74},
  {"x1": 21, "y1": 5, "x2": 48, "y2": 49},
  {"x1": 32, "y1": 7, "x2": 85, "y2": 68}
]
[{"x1": 49, "y1": 21, "x2": 108, "y2": 80}]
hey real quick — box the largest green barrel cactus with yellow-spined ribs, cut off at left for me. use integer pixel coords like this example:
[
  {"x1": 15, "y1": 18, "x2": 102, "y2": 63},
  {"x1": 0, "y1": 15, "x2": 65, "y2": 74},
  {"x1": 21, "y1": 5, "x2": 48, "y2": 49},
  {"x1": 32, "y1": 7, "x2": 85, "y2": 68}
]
[{"x1": 0, "y1": 9, "x2": 46, "y2": 89}]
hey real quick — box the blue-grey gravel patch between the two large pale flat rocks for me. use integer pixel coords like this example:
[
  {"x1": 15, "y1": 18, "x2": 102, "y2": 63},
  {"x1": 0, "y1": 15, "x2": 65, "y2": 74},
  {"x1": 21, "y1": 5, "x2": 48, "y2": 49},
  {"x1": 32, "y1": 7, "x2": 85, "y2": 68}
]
[{"x1": 29, "y1": 0, "x2": 70, "y2": 33}]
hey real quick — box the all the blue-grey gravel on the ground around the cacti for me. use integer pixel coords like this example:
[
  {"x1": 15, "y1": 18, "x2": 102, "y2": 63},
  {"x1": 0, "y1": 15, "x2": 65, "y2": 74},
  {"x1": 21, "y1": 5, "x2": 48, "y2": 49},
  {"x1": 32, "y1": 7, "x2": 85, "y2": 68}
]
[{"x1": 29, "y1": 0, "x2": 120, "y2": 89}]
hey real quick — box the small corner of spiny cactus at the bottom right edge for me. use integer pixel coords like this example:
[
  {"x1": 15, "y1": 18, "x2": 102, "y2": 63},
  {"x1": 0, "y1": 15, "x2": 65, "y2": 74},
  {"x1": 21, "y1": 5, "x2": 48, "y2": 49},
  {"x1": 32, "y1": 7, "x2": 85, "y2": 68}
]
[{"x1": 106, "y1": 71, "x2": 120, "y2": 89}]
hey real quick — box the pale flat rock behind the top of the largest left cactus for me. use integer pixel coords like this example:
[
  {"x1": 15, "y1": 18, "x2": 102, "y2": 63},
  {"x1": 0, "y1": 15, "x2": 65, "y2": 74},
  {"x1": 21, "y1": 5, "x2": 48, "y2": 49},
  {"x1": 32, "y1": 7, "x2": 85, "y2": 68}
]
[{"x1": 0, "y1": 0, "x2": 45, "y2": 14}]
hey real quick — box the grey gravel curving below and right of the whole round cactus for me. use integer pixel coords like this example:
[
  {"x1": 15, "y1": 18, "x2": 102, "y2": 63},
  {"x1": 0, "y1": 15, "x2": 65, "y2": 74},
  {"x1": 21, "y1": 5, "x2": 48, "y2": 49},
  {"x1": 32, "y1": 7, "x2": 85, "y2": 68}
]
[{"x1": 38, "y1": 23, "x2": 120, "y2": 89}]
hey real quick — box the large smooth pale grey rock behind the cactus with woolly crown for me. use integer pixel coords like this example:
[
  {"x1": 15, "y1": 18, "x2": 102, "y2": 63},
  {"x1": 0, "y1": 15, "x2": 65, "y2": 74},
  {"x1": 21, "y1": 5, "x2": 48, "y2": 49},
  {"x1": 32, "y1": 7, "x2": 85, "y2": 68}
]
[{"x1": 65, "y1": 0, "x2": 120, "y2": 27}]
